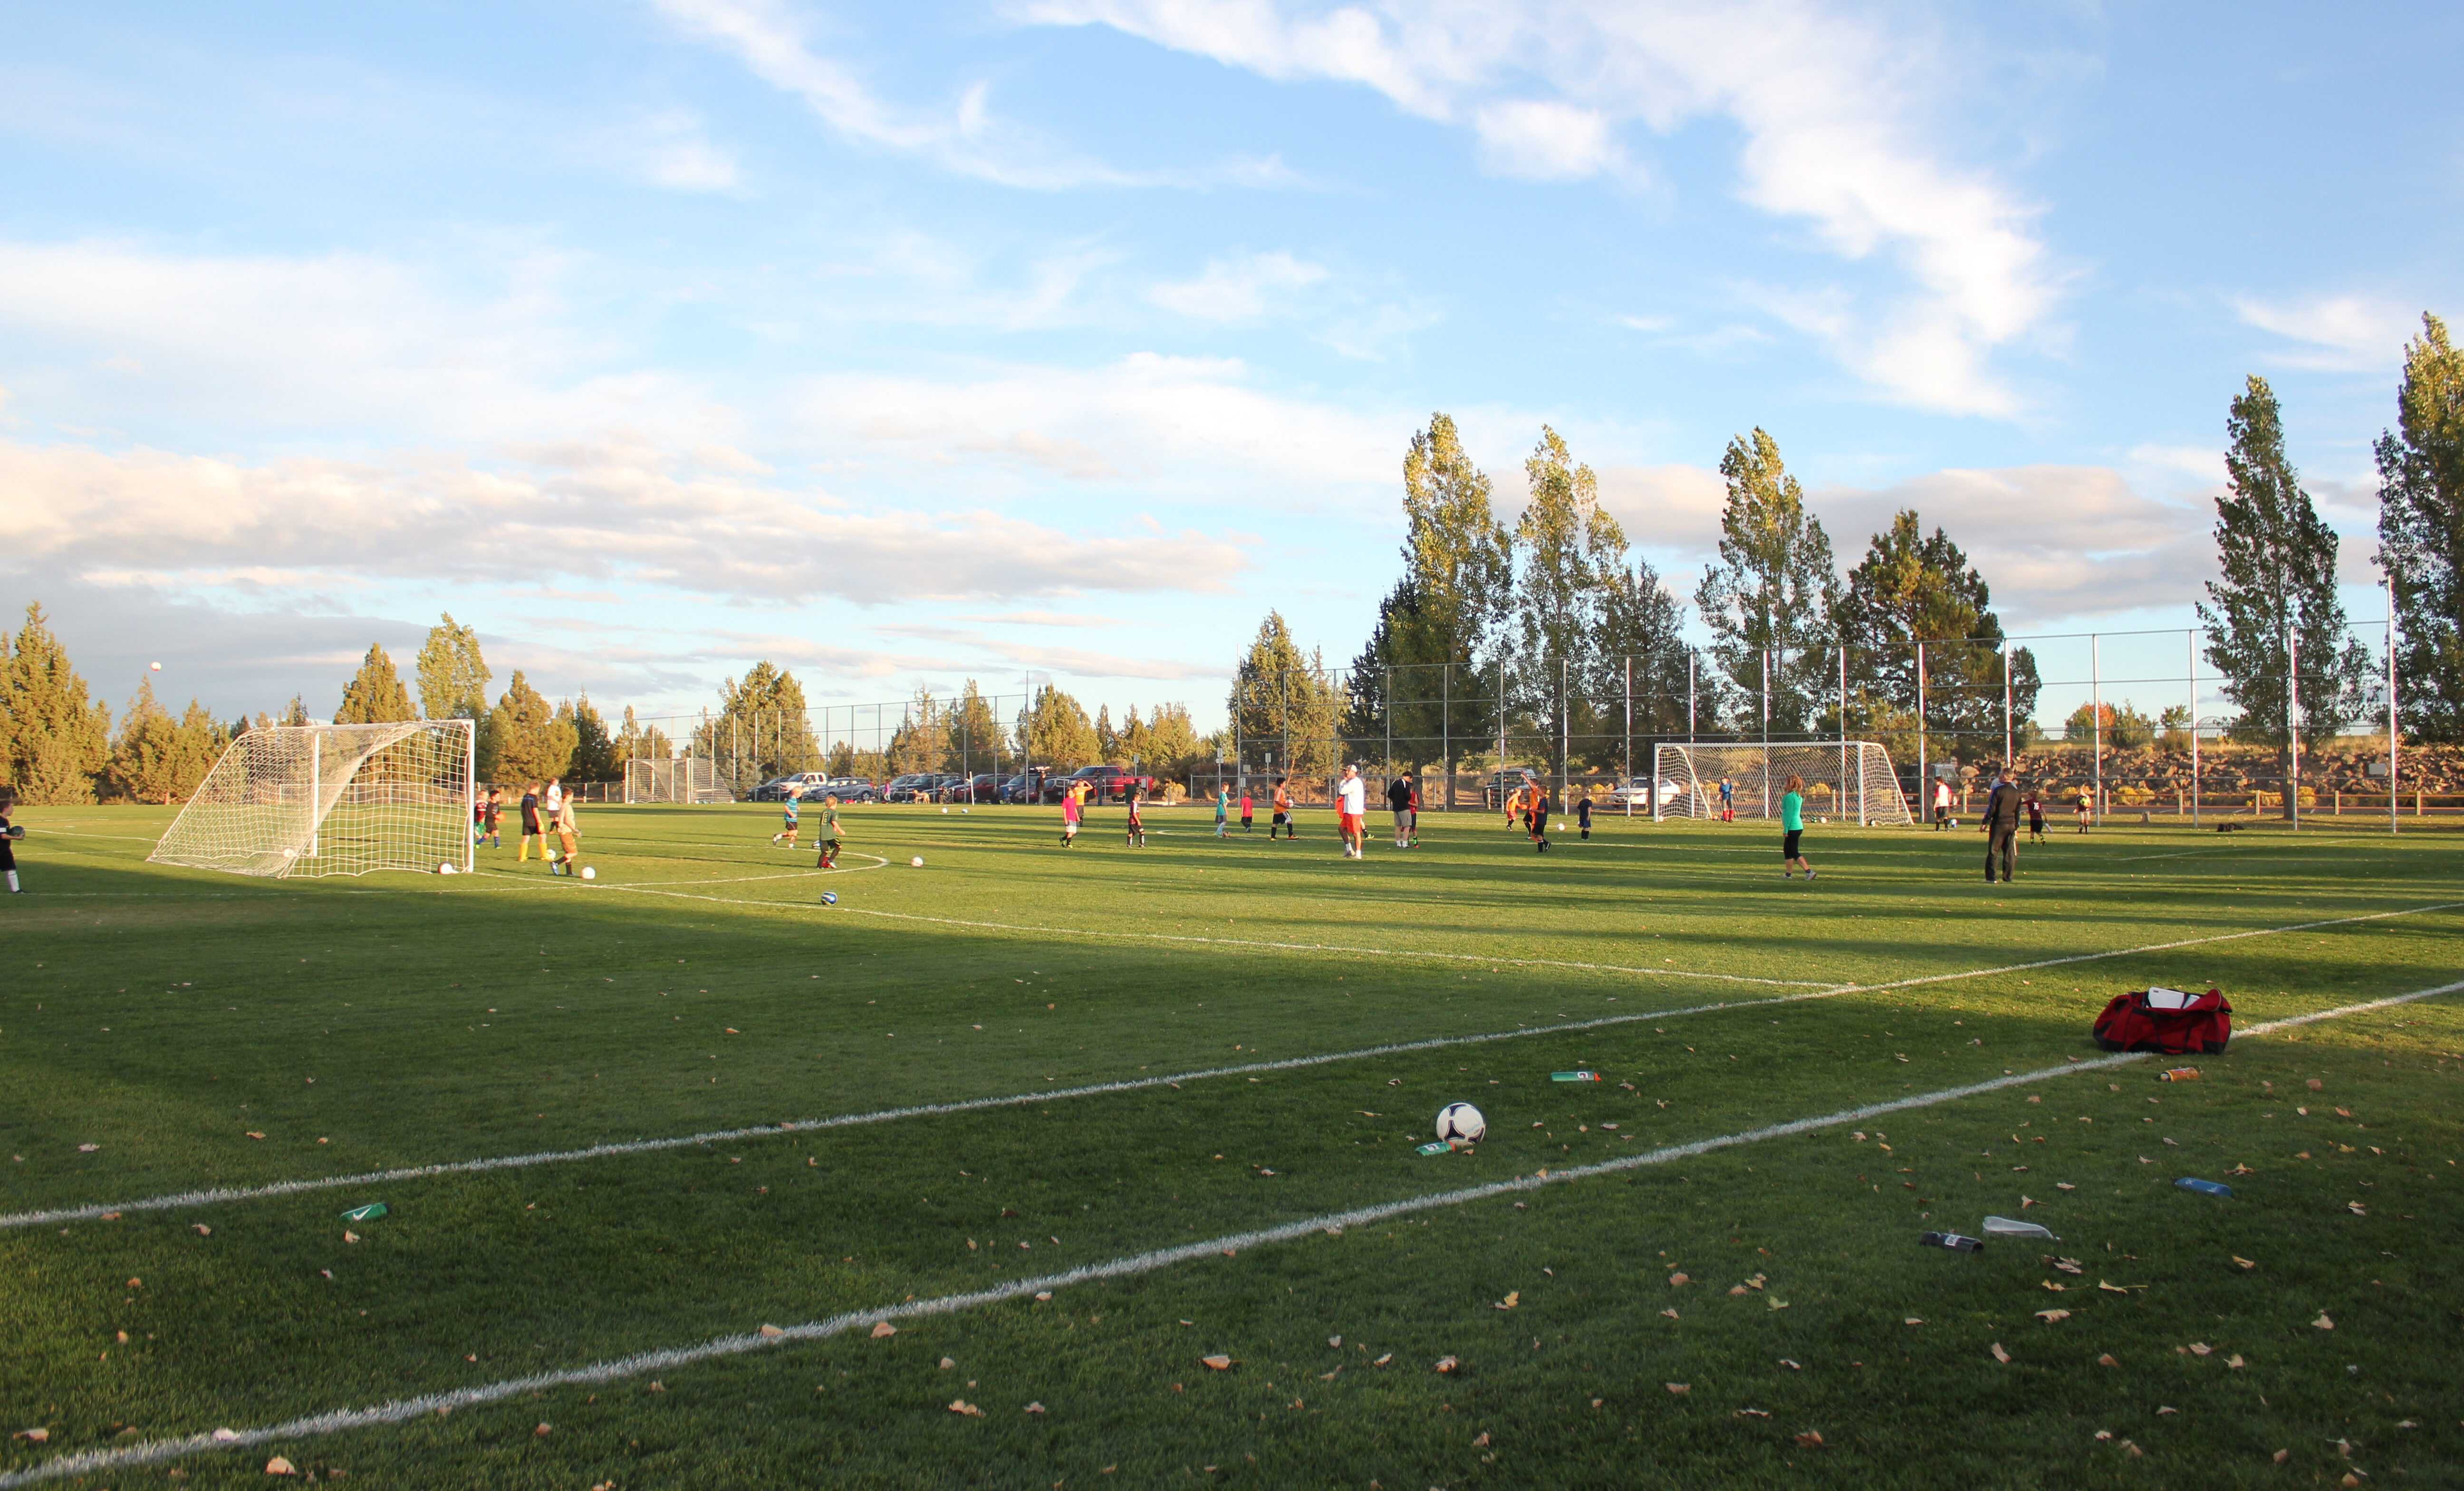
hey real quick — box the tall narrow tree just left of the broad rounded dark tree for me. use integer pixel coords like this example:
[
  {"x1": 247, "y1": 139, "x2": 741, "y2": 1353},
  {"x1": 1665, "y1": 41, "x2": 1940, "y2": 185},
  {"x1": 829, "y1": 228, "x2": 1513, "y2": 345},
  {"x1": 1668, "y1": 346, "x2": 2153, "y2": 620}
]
[{"x1": 1695, "y1": 429, "x2": 1833, "y2": 735}]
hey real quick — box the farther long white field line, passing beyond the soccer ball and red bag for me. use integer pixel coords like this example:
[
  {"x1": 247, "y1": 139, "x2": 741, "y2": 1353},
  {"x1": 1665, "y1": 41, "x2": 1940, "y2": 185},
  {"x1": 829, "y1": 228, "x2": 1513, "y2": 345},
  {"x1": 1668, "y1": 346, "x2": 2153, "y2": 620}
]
[{"x1": 0, "y1": 902, "x2": 2464, "y2": 1232}]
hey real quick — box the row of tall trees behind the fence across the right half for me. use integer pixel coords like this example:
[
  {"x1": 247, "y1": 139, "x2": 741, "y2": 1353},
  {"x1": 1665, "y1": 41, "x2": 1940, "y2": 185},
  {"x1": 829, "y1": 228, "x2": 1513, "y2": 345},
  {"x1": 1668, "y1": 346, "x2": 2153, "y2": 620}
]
[{"x1": 1227, "y1": 315, "x2": 2464, "y2": 774}]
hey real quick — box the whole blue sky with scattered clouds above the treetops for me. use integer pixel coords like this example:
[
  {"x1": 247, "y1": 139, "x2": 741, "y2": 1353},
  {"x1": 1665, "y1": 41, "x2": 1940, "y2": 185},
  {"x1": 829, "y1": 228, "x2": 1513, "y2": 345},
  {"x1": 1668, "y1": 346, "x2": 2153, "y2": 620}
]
[{"x1": 0, "y1": 0, "x2": 2464, "y2": 722}]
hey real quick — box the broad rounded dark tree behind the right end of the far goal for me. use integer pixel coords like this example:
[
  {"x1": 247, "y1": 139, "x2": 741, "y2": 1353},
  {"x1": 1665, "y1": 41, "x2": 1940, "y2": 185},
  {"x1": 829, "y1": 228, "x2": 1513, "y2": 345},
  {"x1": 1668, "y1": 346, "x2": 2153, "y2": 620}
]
[{"x1": 1826, "y1": 510, "x2": 2038, "y2": 756}]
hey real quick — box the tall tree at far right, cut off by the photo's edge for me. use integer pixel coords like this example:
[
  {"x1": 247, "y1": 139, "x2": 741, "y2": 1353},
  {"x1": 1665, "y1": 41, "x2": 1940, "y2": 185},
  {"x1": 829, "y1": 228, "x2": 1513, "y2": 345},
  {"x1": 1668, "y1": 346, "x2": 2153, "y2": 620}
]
[{"x1": 2378, "y1": 315, "x2": 2464, "y2": 742}]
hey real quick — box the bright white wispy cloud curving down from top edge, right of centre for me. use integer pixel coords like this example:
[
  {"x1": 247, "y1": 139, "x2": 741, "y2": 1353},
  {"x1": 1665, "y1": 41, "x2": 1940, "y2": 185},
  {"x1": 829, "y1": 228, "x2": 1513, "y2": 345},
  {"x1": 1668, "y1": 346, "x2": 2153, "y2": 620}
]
[{"x1": 1020, "y1": 0, "x2": 2062, "y2": 414}]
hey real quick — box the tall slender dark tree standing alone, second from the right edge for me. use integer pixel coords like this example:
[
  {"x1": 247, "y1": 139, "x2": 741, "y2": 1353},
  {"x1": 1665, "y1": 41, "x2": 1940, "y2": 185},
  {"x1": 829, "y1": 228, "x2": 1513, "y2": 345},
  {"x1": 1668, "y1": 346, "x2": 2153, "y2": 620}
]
[{"x1": 2198, "y1": 375, "x2": 2370, "y2": 813}]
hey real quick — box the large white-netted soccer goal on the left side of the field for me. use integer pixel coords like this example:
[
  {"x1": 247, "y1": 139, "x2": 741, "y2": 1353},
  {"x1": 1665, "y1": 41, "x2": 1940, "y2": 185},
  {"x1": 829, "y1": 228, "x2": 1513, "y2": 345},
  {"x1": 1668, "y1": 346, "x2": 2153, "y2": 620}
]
[{"x1": 145, "y1": 720, "x2": 476, "y2": 877}]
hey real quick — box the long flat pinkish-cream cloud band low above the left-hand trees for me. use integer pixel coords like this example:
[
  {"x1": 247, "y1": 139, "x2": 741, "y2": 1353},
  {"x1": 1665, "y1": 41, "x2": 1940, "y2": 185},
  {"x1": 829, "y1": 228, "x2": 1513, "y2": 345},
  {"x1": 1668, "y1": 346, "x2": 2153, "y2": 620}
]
[{"x1": 0, "y1": 441, "x2": 1247, "y2": 604}]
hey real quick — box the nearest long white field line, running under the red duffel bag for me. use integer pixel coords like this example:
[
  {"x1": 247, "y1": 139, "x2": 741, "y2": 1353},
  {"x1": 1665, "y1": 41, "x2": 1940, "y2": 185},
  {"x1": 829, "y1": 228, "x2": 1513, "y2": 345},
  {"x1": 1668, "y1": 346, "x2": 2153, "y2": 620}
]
[{"x1": 0, "y1": 981, "x2": 2464, "y2": 1491}]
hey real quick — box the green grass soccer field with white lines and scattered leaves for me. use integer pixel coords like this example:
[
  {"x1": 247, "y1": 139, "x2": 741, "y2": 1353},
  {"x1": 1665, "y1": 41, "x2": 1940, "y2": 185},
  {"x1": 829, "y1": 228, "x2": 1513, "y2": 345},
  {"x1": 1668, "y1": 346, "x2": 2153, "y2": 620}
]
[{"x1": 0, "y1": 808, "x2": 2464, "y2": 1491}]
